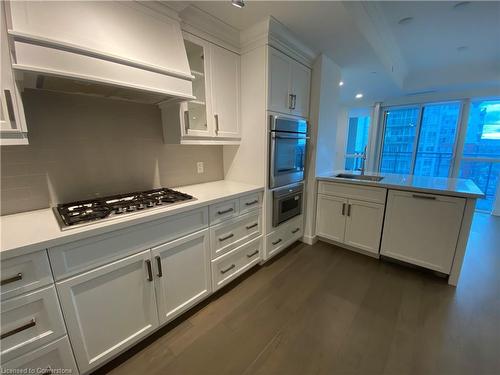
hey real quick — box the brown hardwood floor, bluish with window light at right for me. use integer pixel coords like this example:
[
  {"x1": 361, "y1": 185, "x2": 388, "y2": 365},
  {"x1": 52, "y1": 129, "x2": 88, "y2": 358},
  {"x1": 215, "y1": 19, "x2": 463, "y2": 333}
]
[{"x1": 98, "y1": 214, "x2": 500, "y2": 375}]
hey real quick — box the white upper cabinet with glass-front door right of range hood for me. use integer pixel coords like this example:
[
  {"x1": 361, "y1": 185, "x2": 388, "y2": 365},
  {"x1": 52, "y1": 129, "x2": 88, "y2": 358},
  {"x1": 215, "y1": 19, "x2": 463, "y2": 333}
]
[{"x1": 160, "y1": 33, "x2": 241, "y2": 144}]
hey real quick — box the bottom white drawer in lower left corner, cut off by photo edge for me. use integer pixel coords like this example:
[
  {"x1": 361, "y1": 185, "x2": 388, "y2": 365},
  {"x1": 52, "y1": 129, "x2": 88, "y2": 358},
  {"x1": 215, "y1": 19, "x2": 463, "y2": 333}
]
[{"x1": 2, "y1": 336, "x2": 78, "y2": 374}]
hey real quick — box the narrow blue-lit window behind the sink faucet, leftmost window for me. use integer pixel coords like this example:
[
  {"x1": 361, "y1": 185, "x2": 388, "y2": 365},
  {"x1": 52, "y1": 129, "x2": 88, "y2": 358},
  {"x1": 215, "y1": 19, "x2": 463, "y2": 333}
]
[{"x1": 345, "y1": 110, "x2": 370, "y2": 170}]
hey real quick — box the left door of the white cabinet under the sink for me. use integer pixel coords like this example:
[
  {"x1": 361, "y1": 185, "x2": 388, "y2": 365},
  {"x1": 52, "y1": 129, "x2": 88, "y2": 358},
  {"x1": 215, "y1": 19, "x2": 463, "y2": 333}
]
[{"x1": 316, "y1": 195, "x2": 347, "y2": 242}]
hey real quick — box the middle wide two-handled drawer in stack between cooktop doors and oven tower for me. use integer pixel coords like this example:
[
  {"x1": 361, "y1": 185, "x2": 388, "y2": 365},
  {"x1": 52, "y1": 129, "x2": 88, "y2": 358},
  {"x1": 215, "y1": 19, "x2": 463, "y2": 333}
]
[{"x1": 210, "y1": 210, "x2": 262, "y2": 259}]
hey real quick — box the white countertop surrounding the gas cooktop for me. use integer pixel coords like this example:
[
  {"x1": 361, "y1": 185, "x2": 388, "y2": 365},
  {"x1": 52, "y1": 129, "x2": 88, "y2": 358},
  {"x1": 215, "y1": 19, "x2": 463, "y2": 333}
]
[{"x1": 0, "y1": 180, "x2": 264, "y2": 258}]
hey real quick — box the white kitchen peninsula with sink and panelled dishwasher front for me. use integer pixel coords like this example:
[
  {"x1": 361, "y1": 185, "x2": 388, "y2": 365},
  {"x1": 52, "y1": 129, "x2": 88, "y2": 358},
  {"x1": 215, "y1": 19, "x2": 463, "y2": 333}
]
[{"x1": 316, "y1": 171, "x2": 483, "y2": 285}]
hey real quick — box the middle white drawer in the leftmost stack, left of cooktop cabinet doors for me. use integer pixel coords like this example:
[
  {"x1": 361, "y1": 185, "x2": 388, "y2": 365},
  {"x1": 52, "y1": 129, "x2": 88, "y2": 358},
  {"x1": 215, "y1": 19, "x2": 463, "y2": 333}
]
[{"x1": 1, "y1": 285, "x2": 66, "y2": 361}]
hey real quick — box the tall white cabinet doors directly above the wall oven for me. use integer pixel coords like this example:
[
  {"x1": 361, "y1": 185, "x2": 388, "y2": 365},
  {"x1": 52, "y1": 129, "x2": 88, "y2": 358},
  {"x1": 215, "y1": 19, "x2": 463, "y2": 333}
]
[{"x1": 268, "y1": 47, "x2": 311, "y2": 118}]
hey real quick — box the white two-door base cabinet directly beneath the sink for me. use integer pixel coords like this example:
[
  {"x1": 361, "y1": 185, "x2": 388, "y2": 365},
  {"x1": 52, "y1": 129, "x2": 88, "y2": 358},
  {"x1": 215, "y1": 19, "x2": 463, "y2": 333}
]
[{"x1": 316, "y1": 182, "x2": 386, "y2": 255}]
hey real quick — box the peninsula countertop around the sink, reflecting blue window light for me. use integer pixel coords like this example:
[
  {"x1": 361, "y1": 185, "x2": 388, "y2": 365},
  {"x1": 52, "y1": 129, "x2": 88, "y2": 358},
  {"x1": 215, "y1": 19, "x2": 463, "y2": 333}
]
[{"x1": 316, "y1": 170, "x2": 484, "y2": 198}]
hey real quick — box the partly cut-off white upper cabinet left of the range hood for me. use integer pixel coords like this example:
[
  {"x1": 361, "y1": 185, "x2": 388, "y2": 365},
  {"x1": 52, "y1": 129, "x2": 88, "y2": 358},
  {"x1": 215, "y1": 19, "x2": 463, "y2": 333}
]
[{"x1": 0, "y1": 1, "x2": 28, "y2": 146}]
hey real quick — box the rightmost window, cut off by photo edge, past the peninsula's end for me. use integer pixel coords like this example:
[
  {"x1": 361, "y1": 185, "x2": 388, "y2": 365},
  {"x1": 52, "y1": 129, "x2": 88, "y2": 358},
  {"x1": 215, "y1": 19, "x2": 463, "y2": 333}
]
[{"x1": 459, "y1": 100, "x2": 500, "y2": 212}]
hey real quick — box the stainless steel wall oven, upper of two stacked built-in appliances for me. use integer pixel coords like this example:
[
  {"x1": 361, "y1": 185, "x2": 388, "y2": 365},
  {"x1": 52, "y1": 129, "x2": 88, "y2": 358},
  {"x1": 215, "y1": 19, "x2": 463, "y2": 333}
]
[{"x1": 269, "y1": 115, "x2": 309, "y2": 189}]
